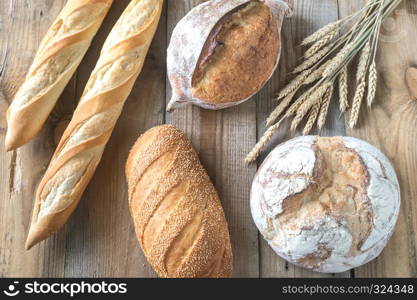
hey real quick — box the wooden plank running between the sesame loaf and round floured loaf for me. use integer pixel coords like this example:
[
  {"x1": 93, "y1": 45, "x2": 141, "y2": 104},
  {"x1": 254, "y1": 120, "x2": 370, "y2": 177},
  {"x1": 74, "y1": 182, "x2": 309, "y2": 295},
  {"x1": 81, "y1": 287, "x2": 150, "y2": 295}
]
[{"x1": 166, "y1": 0, "x2": 259, "y2": 277}]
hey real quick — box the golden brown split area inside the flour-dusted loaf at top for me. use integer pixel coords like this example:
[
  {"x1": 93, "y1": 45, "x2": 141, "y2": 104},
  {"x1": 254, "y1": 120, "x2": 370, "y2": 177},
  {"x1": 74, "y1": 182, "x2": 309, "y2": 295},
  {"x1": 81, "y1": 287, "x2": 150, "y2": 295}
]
[{"x1": 193, "y1": 1, "x2": 280, "y2": 103}]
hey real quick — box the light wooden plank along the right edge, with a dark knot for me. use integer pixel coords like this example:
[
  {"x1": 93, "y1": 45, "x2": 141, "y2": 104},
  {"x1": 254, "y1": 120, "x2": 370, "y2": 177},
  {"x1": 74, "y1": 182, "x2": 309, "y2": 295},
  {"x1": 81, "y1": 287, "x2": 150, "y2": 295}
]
[{"x1": 339, "y1": 0, "x2": 417, "y2": 277}]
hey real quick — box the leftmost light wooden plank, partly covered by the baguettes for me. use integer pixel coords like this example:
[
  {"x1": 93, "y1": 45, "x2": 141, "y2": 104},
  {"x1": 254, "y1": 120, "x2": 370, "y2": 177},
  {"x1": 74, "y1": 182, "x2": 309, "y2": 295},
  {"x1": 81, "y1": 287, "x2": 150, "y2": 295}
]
[{"x1": 0, "y1": 0, "x2": 71, "y2": 277}]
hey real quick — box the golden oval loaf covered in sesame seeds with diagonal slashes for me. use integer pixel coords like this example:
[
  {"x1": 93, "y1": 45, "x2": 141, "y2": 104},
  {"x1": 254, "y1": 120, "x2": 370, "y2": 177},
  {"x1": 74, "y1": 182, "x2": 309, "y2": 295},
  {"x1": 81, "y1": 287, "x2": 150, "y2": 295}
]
[{"x1": 126, "y1": 125, "x2": 232, "y2": 277}]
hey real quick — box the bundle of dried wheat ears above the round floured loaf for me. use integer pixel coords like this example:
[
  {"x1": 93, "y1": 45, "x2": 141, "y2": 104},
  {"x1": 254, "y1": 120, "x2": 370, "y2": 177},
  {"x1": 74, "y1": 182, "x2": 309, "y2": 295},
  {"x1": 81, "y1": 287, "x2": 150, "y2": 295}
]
[{"x1": 246, "y1": 0, "x2": 401, "y2": 163}]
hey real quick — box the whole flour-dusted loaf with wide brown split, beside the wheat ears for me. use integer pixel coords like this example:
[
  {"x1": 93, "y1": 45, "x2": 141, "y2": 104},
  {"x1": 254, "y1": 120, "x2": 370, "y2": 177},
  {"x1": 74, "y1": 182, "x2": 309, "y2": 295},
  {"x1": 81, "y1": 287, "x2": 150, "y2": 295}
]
[{"x1": 167, "y1": 0, "x2": 292, "y2": 110}]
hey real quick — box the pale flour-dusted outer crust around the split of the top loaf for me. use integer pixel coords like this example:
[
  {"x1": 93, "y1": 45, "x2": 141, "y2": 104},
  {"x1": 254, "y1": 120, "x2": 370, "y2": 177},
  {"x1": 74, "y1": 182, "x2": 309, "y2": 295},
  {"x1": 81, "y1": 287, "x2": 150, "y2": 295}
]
[{"x1": 167, "y1": 0, "x2": 293, "y2": 111}]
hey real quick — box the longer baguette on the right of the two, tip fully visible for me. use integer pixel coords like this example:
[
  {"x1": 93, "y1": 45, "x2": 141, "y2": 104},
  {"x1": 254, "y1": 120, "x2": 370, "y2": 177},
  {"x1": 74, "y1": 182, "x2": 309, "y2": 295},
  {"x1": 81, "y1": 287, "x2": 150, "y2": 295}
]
[{"x1": 26, "y1": 0, "x2": 163, "y2": 248}]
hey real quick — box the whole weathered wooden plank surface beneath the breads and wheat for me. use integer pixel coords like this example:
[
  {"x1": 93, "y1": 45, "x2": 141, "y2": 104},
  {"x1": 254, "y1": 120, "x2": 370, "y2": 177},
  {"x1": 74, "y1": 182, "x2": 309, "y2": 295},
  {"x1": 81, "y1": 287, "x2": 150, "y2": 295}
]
[{"x1": 0, "y1": 0, "x2": 417, "y2": 277}]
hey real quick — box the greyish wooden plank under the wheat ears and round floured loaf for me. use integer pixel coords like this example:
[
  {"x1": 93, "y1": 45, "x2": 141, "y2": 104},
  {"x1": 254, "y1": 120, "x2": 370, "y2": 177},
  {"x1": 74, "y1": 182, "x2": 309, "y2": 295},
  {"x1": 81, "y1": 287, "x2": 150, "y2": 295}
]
[{"x1": 257, "y1": 0, "x2": 350, "y2": 277}]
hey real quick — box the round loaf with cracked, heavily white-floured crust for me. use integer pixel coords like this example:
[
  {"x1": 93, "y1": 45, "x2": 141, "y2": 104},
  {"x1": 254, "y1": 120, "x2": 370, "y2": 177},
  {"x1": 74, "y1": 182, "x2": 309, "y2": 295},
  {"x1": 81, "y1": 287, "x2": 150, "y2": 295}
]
[{"x1": 251, "y1": 136, "x2": 400, "y2": 273}]
